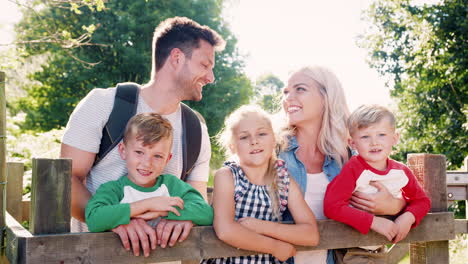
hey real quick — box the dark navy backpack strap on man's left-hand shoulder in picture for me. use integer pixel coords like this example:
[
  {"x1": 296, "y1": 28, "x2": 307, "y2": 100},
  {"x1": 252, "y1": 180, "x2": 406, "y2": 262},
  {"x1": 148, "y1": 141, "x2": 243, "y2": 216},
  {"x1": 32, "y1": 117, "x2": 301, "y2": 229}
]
[{"x1": 94, "y1": 82, "x2": 140, "y2": 165}]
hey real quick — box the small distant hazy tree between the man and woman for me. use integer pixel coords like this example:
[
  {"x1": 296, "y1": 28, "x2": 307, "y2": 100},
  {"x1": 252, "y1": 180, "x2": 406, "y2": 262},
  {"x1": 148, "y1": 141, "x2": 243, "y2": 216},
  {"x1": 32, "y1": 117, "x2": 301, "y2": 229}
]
[{"x1": 255, "y1": 73, "x2": 284, "y2": 113}]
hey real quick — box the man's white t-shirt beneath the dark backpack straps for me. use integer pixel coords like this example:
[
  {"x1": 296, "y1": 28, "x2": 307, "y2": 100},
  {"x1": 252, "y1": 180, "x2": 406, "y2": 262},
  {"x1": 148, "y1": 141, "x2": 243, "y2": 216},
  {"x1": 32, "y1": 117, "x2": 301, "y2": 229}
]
[{"x1": 62, "y1": 88, "x2": 211, "y2": 232}]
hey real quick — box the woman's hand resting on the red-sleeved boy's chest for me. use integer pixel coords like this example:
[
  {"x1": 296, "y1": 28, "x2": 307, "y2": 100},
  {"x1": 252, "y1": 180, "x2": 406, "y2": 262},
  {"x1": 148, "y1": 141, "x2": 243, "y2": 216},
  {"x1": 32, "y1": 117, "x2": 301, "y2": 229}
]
[{"x1": 349, "y1": 182, "x2": 406, "y2": 215}]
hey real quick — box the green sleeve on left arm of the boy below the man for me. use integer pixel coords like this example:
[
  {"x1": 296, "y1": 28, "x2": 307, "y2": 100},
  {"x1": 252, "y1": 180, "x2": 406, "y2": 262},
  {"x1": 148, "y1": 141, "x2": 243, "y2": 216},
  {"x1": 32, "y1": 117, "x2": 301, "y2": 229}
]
[{"x1": 85, "y1": 181, "x2": 130, "y2": 232}]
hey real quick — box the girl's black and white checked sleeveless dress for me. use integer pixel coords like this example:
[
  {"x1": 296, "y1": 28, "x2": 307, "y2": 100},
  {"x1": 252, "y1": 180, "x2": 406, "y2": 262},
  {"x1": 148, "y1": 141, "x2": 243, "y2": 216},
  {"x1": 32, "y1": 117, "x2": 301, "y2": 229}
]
[{"x1": 201, "y1": 160, "x2": 289, "y2": 264}]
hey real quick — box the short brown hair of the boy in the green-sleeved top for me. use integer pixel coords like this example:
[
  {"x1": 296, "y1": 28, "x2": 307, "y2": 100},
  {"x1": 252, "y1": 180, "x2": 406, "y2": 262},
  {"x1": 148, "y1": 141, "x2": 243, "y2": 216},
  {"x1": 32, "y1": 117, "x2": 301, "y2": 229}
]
[{"x1": 123, "y1": 113, "x2": 172, "y2": 146}]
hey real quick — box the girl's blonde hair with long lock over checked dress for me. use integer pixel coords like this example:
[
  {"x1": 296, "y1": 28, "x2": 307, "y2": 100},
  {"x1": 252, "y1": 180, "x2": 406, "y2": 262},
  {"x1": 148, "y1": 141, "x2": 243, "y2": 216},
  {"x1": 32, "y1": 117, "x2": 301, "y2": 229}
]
[{"x1": 216, "y1": 105, "x2": 280, "y2": 219}]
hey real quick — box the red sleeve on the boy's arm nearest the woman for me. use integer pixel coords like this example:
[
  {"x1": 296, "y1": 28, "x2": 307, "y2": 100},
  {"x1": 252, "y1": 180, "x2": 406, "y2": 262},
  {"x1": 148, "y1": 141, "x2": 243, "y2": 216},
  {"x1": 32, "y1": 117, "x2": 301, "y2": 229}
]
[{"x1": 323, "y1": 163, "x2": 374, "y2": 234}]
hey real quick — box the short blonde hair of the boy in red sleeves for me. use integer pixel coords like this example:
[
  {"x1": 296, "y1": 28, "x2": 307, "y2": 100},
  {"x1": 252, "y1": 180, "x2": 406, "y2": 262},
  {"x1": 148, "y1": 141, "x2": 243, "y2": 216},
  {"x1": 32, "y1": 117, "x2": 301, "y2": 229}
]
[{"x1": 347, "y1": 104, "x2": 396, "y2": 135}]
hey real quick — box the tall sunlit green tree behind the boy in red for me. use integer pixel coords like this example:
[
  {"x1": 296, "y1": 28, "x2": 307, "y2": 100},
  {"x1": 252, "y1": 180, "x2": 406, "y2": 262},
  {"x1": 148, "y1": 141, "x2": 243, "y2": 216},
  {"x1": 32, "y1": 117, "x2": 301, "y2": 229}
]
[{"x1": 360, "y1": 0, "x2": 468, "y2": 169}]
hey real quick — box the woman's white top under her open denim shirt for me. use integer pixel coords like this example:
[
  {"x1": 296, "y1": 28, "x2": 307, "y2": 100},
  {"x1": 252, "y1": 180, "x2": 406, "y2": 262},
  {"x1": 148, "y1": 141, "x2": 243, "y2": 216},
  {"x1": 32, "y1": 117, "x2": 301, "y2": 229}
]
[{"x1": 294, "y1": 171, "x2": 330, "y2": 264}]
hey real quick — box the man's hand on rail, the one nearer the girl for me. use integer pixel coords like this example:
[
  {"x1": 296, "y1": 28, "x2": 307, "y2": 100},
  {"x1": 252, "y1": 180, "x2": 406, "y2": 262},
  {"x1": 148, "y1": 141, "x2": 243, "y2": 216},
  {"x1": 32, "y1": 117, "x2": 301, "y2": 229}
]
[{"x1": 156, "y1": 219, "x2": 193, "y2": 248}]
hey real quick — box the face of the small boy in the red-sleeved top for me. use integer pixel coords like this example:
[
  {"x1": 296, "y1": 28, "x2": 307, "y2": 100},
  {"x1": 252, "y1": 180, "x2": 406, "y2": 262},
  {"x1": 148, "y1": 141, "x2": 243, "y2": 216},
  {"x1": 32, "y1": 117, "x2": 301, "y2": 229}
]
[{"x1": 350, "y1": 118, "x2": 399, "y2": 170}]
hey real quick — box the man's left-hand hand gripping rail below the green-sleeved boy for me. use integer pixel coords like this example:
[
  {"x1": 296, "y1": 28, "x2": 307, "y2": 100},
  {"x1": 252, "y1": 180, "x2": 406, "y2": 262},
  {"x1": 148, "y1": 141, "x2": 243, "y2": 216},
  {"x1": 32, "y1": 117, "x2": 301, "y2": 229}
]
[{"x1": 112, "y1": 219, "x2": 157, "y2": 257}]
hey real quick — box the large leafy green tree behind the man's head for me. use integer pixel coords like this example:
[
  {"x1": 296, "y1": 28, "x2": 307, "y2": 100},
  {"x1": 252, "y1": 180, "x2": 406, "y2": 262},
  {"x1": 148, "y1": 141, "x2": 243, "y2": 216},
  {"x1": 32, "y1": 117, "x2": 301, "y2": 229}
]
[{"x1": 13, "y1": 0, "x2": 252, "y2": 134}]
